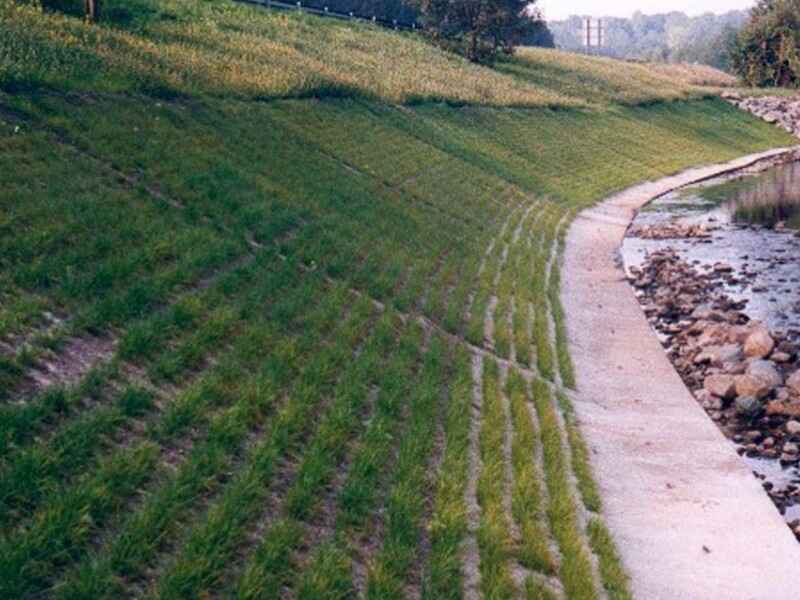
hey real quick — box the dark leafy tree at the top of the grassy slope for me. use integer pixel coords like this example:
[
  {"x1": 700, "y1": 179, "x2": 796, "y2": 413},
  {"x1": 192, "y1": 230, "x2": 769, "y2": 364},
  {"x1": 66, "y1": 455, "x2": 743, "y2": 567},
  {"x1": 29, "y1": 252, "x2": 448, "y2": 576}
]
[{"x1": 410, "y1": 0, "x2": 536, "y2": 62}]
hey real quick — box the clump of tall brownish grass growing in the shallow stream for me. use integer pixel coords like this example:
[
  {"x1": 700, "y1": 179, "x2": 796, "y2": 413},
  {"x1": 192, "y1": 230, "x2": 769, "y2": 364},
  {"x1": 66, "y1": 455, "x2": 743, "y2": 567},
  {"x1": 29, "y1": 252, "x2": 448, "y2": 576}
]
[{"x1": 703, "y1": 162, "x2": 800, "y2": 229}]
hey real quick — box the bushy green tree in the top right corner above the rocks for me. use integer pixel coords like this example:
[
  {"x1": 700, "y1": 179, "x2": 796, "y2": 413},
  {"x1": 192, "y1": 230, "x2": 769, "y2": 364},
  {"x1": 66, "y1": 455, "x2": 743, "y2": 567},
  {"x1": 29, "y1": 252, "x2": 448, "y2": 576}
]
[{"x1": 731, "y1": 0, "x2": 800, "y2": 87}]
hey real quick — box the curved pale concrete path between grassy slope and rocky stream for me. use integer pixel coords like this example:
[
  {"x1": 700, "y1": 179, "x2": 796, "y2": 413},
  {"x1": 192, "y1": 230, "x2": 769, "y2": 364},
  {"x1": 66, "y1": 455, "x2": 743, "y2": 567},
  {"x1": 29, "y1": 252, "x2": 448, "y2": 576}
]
[{"x1": 562, "y1": 150, "x2": 800, "y2": 600}]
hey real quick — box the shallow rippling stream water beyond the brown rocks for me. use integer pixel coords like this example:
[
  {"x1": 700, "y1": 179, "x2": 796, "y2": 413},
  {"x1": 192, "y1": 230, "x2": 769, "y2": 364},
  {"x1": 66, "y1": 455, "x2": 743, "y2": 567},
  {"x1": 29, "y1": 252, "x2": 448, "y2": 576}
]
[{"x1": 622, "y1": 162, "x2": 800, "y2": 339}]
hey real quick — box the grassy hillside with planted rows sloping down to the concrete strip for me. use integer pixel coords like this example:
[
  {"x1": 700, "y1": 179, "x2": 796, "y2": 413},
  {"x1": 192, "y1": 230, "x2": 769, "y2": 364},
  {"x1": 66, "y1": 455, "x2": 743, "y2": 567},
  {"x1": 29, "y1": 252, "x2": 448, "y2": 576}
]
[{"x1": 0, "y1": 0, "x2": 790, "y2": 599}]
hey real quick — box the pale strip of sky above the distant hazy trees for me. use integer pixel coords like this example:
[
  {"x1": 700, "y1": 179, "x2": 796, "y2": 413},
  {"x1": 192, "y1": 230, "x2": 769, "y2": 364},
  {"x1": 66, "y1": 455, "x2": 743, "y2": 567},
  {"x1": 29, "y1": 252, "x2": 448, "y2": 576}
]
[{"x1": 536, "y1": 0, "x2": 755, "y2": 21}]
